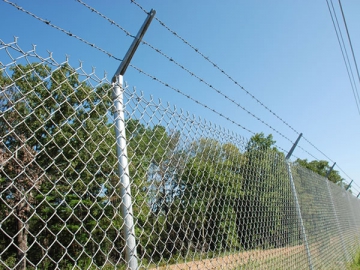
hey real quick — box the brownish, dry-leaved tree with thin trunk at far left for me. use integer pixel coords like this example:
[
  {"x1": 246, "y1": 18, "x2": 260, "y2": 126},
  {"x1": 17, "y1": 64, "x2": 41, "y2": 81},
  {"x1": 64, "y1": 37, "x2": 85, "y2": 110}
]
[{"x1": 0, "y1": 136, "x2": 44, "y2": 269}]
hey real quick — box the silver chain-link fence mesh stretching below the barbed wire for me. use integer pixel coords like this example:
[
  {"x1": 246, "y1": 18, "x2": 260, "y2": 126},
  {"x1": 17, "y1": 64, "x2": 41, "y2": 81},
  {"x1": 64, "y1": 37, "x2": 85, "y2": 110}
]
[{"x1": 0, "y1": 41, "x2": 360, "y2": 269}]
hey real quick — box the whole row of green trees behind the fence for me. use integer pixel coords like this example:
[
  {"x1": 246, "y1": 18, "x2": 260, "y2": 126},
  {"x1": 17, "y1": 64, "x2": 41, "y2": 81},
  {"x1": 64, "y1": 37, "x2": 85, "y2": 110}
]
[{"x1": 0, "y1": 63, "x2": 341, "y2": 269}]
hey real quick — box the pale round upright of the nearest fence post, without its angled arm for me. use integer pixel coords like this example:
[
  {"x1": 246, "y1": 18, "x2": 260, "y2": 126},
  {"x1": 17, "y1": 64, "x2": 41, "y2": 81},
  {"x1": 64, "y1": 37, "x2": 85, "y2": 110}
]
[{"x1": 113, "y1": 75, "x2": 138, "y2": 270}]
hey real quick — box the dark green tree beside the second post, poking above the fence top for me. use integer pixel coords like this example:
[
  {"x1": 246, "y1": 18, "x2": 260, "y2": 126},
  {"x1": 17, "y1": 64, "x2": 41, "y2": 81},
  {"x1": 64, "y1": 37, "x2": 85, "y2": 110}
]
[{"x1": 237, "y1": 133, "x2": 295, "y2": 249}]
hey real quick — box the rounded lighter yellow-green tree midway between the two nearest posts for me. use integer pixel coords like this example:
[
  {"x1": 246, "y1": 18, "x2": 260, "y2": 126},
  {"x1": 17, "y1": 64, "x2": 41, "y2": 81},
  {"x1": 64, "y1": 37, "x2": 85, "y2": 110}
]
[{"x1": 180, "y1": 138, "x2": 243, "y2": 252}]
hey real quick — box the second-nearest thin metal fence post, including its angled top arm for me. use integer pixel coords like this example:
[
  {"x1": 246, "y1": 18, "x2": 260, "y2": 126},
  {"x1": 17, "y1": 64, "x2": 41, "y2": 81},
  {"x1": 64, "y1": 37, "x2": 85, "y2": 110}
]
[{"x1": 286, "y1": 133, "x2": 313, "y2": 270}]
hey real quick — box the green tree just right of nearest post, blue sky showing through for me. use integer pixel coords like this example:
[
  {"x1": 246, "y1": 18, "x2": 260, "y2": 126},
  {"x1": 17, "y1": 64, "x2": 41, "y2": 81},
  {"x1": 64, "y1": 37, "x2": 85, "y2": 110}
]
[{"x1": 126, "y1": 119, "x2": 183, "y2": 261}]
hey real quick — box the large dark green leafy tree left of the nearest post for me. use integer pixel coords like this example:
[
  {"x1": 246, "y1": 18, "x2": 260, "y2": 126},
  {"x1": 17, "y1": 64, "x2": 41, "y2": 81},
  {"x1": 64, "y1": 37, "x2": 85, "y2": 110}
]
[{"x1": 0, "y1": 63, "x2": 116, "y2": 269}]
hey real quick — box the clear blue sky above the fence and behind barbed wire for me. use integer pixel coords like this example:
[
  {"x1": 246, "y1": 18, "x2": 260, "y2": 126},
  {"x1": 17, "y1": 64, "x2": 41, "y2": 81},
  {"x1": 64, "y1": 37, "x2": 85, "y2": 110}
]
[{"x1": 0, "y1": 0, "x2": 360, "y2": 191}]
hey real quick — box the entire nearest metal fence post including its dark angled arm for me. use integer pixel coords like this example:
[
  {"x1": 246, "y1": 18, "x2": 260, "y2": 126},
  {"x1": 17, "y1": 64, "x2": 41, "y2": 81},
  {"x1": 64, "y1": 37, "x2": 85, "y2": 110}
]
[{"x1": 112, "y1": 9, "x2": 156, "y2": 270}]
